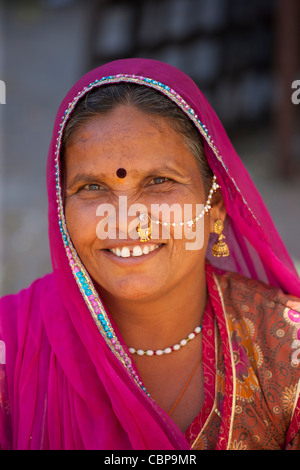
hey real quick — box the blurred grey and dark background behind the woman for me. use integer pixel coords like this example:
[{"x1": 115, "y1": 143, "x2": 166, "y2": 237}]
[{"x1": 0, "y1": 0, "x2": 300, "y2": 295}]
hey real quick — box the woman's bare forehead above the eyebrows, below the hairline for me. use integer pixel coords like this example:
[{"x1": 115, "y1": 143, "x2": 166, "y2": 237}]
[{"x1": 62, "y1": 107, "x2": 196, "y2": 177}]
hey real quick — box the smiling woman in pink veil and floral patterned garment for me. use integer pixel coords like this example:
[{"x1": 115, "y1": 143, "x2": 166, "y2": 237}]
[{"x1": 0, "y1": 59, "x2": 300, "y2": 450}]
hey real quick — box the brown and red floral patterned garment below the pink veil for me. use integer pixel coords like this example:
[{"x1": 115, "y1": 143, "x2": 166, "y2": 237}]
[{"x1": 186, "y1": 267, "x2": 300, "y2": 450}]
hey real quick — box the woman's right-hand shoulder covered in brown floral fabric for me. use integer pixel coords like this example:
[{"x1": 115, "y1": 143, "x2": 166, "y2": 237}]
[{"x1": 213, "y1": 266, "x2": 300, "y2": 376}]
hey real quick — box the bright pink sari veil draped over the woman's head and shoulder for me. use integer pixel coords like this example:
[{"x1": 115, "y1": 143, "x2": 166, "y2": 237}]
[{"x1": 0, "y1": 59, "x2": 300, "y2": 450}]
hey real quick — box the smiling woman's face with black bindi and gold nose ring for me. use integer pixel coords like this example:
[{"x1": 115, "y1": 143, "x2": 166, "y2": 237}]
[{"x1": 65, "y1": 106, "x2": 209, "y2": 300}]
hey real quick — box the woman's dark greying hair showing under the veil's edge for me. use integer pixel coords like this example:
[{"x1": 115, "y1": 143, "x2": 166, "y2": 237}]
[{"x1": 61, "y1": 83, "x2": 213, "y2": 192}]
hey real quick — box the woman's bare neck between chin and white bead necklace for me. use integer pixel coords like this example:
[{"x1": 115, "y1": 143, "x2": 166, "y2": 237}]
[{"x1": 100, "y1": 270, "x2": 207, "y2": 349}]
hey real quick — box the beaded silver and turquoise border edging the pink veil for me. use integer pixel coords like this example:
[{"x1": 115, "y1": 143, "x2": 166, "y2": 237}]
[{"x1": 55, "y1": 74, "x2": 260, "y2": 395}]
